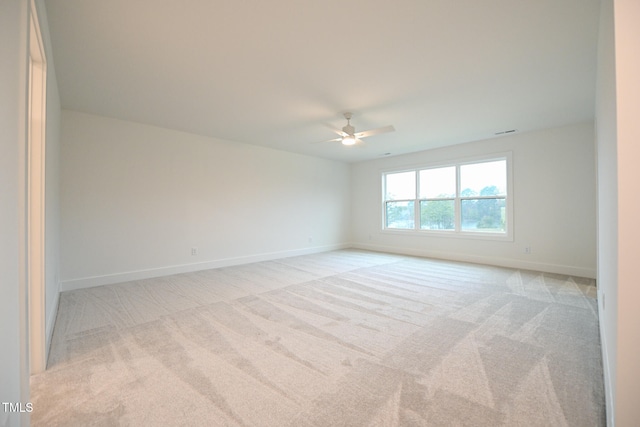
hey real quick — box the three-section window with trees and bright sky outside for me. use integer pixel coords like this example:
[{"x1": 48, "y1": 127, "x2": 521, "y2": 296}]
[{"x1": 382, "y1": 155, "x2": 511, "y2": 237}]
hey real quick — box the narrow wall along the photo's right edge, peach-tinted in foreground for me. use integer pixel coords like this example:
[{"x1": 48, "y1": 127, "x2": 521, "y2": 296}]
[{"x1": 596, "y1": 0, "x2": 640, "y2": 427}]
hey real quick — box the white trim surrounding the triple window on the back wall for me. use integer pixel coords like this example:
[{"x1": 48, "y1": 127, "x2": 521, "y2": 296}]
[{"x1": 380, "y1": 151, "x2": 514, "y2": 242}]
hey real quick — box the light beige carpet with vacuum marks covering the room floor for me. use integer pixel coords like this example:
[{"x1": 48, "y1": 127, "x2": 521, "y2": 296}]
[{"x1": 31, "y1": 250, "x2": 605, "y2": 427}]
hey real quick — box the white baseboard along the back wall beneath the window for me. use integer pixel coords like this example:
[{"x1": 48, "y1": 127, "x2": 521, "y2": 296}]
[{"x1": 351, "y1": 243, "x2": 596, "y2": 279}]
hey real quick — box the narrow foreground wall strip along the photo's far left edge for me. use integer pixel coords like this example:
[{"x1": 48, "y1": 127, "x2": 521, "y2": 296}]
[{"x1": 0, "y1": 0, "x2": 29, "y2": 426}]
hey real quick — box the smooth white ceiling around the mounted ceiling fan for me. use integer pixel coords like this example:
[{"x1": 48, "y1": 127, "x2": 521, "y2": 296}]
[{"x1": 45, "y1": 0, "x2": 599, "y2": 162}]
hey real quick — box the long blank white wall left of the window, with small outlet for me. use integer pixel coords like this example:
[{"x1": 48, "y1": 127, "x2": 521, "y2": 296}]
[{"x1": 61, "y1": 110, "x2": 350, "y2": 290}]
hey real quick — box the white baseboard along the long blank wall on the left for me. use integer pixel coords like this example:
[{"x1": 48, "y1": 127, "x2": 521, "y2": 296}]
[{"x1": 60, "y1": 243, "x2": 350, "y2": 292}]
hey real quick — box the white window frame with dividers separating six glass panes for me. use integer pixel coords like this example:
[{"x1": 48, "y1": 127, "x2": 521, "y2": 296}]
[{"x1": 380, "y1": 151, "x2": 514, "y2": 241}]
